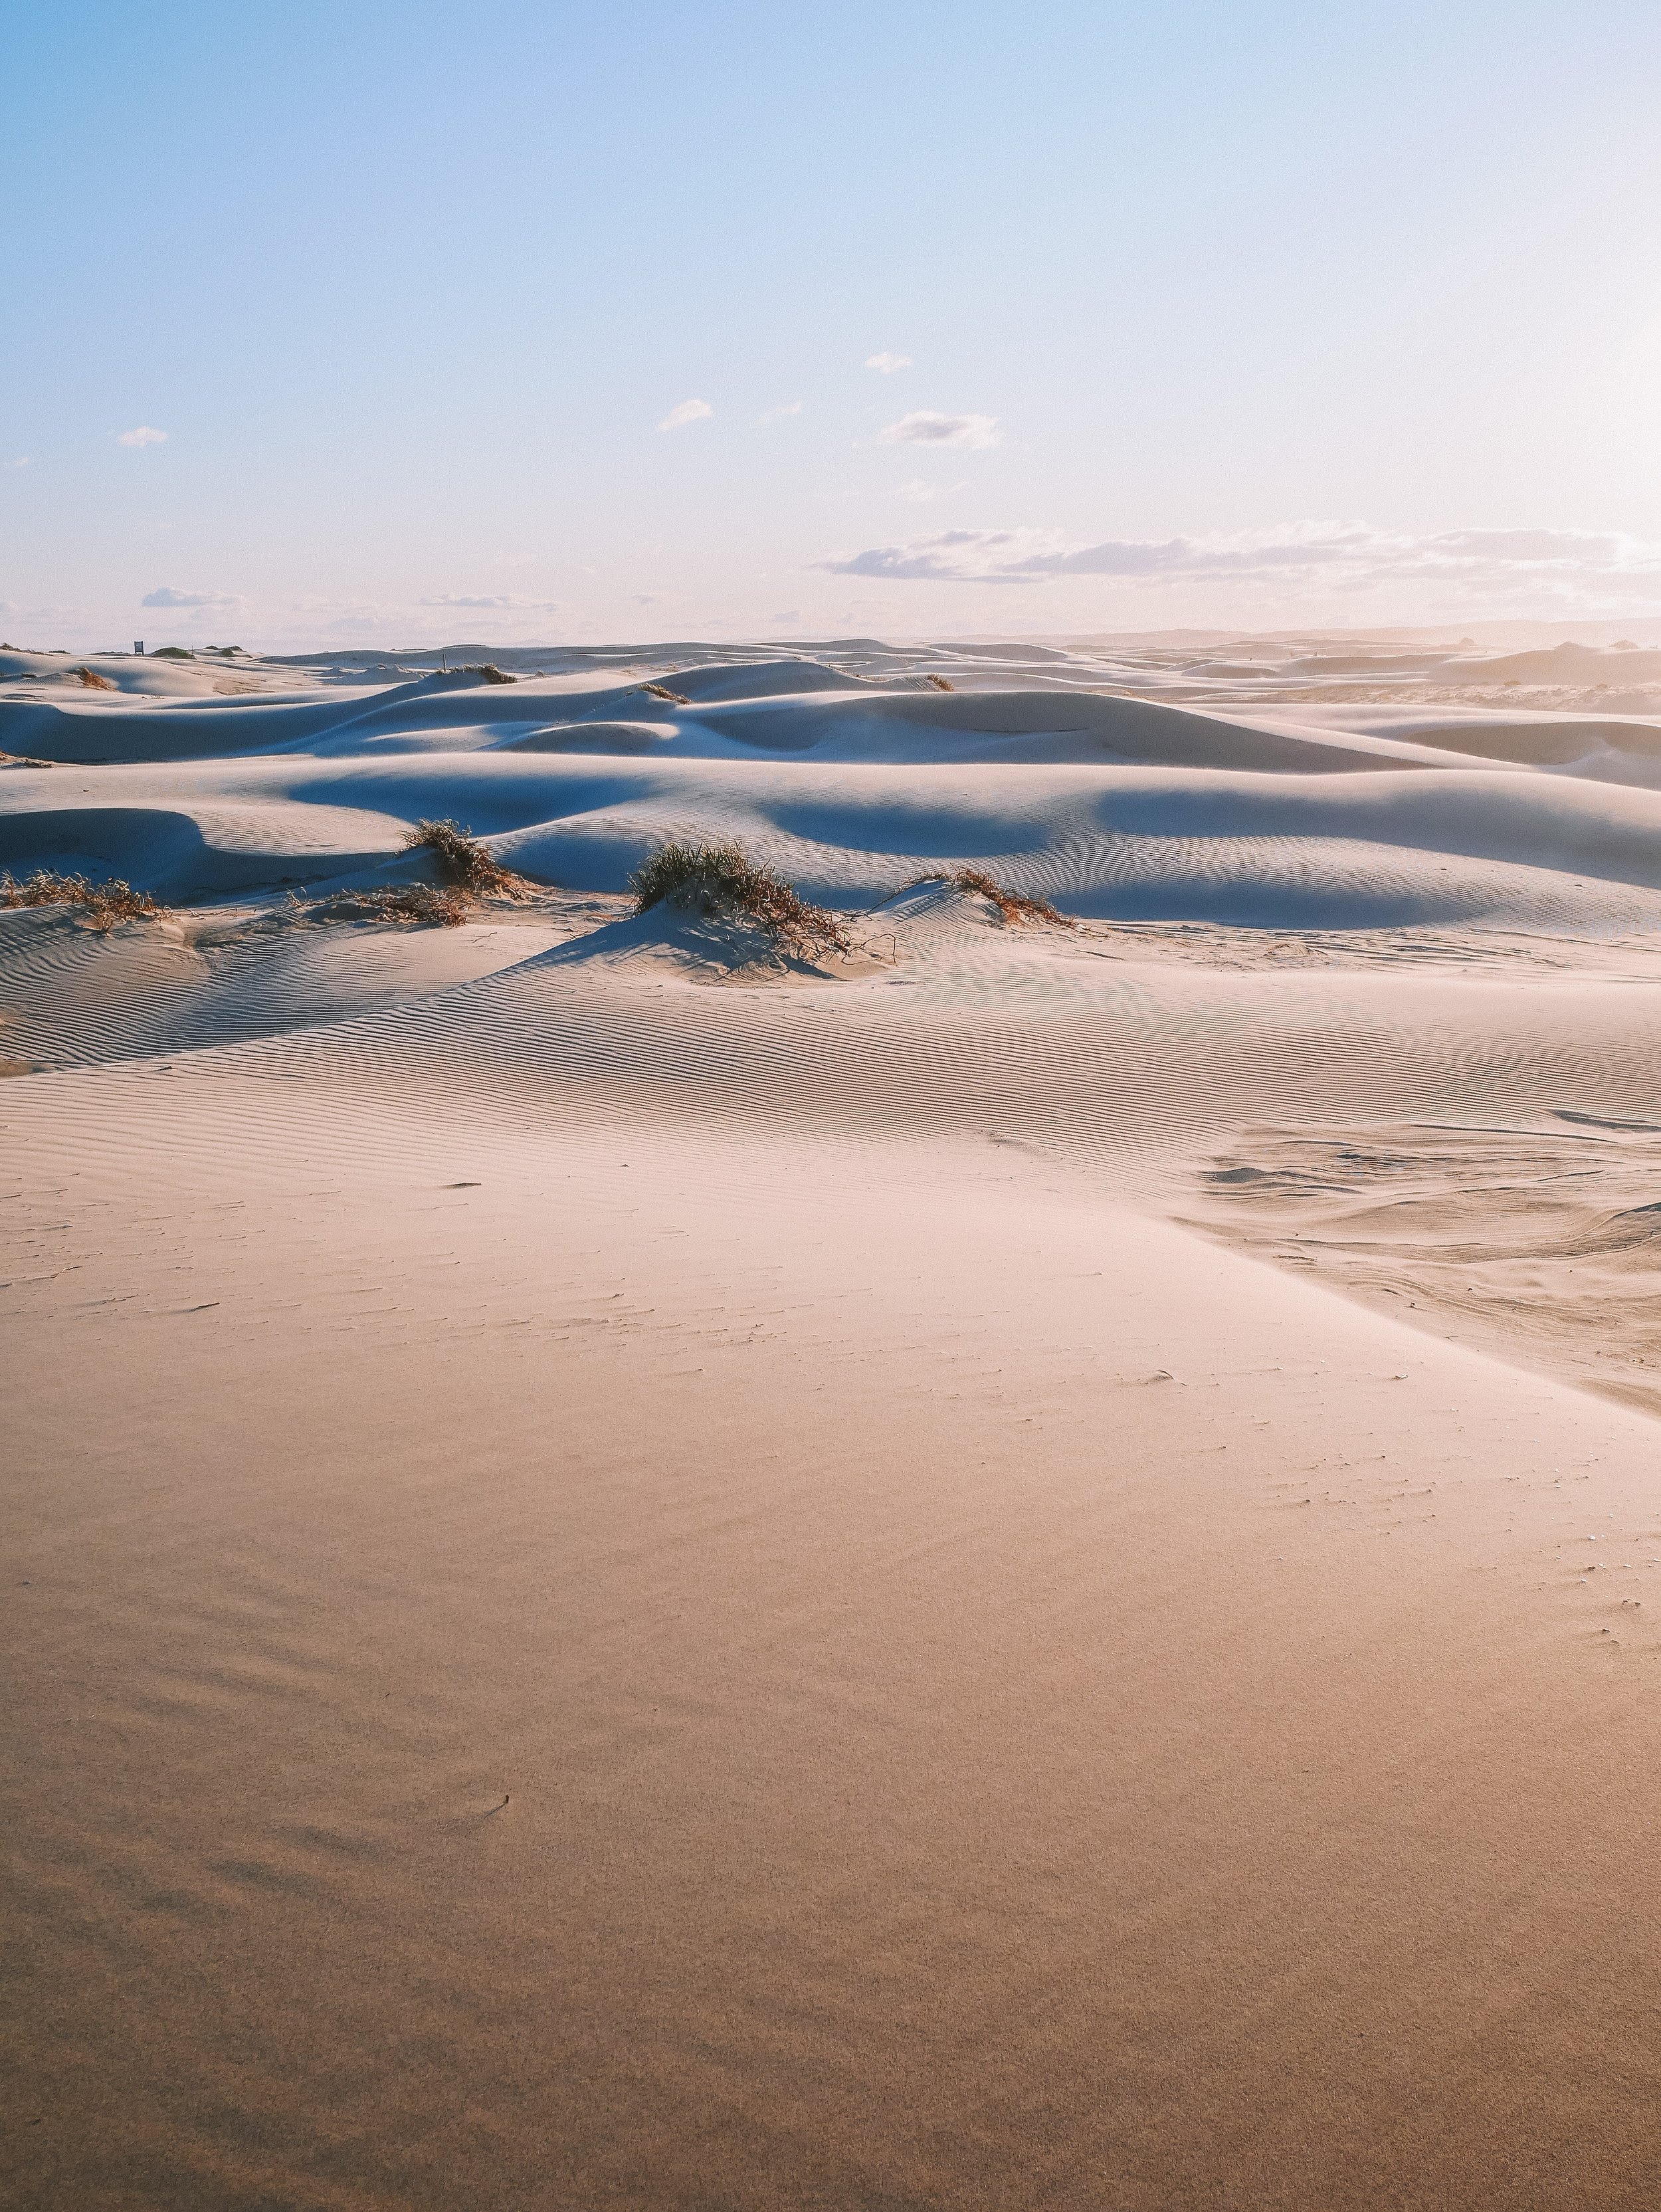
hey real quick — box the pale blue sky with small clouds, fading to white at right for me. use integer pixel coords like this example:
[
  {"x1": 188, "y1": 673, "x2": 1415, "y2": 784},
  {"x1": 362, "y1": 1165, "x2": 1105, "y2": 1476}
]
[{"x1": 0, "y1": 0, "x2": 1661, "y2": 651}]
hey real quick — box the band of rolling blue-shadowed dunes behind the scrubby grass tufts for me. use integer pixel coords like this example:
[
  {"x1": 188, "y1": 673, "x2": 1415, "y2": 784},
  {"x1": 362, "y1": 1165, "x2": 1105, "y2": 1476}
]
[{"x1": 0, "y1": 641, "x2": 1661, "y2": 932}]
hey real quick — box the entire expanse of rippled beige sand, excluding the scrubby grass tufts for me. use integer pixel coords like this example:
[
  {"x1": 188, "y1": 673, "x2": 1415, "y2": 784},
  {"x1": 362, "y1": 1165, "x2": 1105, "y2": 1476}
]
[{"x1": 0, "y1": 639, "x2": 1661, "y2": 2212}]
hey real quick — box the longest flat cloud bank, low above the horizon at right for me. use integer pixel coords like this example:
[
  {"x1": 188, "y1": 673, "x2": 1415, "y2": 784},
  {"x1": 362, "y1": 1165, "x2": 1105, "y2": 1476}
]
[{"x1": 819, "y1": 522, "x2": 1661, "y2": 604}]
